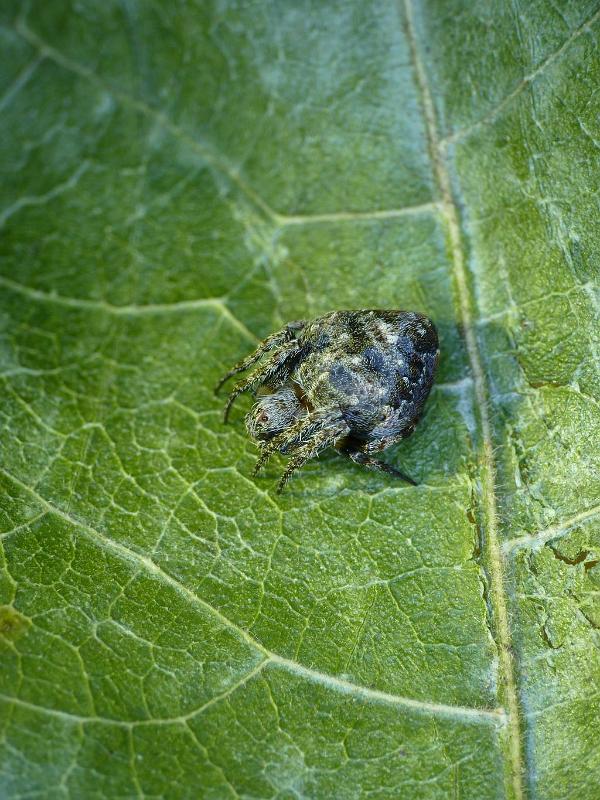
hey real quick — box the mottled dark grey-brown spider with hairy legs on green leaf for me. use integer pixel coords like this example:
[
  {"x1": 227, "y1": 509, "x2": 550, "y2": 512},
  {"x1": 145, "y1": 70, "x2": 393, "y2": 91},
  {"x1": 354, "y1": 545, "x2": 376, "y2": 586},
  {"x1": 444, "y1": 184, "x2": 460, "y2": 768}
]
[{"x1": 215, "y1": 309, "x2": 439, "y2": 492}]
